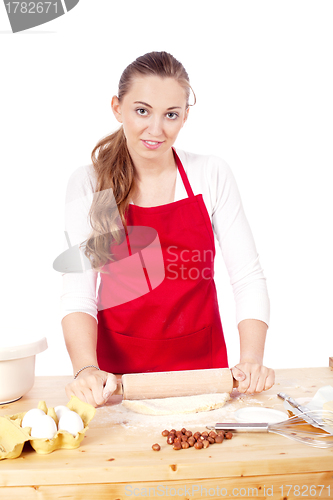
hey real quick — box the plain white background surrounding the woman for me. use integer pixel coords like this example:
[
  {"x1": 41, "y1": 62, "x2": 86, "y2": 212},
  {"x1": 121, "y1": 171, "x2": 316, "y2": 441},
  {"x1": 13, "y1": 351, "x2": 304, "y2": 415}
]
[{"x1": 0, "y1": 0, "x2": 333, "y2": 375}]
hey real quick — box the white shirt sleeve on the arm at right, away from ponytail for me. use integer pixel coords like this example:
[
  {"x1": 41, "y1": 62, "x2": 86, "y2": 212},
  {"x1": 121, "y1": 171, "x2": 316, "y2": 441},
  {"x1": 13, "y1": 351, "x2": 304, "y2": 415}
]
[{"x1": 206, "y1": 157, "x2": 270, "y2": 325}]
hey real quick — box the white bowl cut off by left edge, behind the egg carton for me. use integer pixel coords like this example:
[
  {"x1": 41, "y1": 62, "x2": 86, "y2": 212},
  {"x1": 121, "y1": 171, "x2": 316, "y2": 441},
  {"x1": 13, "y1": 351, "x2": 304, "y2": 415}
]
[{"x1": 0, "y1": 337, "x2": 47, "y2": 404}]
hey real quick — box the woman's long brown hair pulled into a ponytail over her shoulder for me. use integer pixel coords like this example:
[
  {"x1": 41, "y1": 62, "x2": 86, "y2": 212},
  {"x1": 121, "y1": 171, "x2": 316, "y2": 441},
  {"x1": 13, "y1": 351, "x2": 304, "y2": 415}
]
[{"x1": 85, "y1": 52, "x2": 196, "y2": 271}]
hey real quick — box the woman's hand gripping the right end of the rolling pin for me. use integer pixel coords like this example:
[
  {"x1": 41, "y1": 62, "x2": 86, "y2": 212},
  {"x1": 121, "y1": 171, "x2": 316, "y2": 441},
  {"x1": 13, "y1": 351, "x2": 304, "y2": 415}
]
[{"x1": 231, "y1": 362, "x2": 275, "y2": 394}]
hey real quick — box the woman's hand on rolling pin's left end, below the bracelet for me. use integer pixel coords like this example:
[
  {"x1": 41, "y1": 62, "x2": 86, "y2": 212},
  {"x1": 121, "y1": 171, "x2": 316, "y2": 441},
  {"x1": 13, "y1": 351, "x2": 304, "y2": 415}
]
[{"x1": 66, "y1": 368, "x2": 117, "y2": 407}]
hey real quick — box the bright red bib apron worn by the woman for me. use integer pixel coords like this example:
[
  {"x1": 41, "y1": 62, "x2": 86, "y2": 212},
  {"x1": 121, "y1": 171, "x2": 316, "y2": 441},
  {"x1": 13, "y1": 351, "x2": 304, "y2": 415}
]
[{"x1": 97, "y1": 150, "x2": 228, "y2": 373}]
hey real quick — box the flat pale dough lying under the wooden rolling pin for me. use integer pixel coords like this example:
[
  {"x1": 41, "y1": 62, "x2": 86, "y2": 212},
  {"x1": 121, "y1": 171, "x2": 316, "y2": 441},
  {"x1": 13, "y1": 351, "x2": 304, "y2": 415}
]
[{"x1": 122, "y1": 392, "x2": 230, "y2": 415}]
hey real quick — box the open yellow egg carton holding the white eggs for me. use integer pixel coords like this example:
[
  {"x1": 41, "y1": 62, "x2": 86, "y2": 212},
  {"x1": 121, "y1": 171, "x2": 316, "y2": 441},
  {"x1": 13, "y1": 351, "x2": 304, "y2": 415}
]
[{"x1": 0, "y1": 396, "x2": 96, "y2": 460}]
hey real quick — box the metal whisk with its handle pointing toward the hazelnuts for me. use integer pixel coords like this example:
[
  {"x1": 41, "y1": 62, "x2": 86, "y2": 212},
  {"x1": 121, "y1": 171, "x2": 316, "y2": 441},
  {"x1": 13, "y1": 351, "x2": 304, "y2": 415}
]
[{"x1": 207, "y1": 410, "x2": 333, "y2": 448}]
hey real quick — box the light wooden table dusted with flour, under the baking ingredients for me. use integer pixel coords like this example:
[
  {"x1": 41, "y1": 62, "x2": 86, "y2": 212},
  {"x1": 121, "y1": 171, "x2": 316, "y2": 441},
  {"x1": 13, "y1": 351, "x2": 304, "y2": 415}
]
[{"x1": 0, "y1": 367, "x2": 333, "y2": 500}]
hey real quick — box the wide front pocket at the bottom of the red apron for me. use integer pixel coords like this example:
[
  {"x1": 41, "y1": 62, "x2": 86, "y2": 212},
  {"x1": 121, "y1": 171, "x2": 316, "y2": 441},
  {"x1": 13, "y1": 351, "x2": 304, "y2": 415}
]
[{"x1": 97, "y1": 326, "x2": 213, "y2": 374}]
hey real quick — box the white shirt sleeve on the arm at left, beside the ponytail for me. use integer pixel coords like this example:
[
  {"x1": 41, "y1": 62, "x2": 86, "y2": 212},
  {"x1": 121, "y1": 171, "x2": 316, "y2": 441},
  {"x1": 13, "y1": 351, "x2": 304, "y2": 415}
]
[{"x1": 60, "y1": 166, "x2": 98, "y2": 321}]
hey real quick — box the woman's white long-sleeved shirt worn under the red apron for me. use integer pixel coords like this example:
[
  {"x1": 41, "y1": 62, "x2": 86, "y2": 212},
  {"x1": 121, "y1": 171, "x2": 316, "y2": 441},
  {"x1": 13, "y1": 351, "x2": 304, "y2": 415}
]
[{"x1": 60, "y1": 149, "x2": 270, "y2": 325}]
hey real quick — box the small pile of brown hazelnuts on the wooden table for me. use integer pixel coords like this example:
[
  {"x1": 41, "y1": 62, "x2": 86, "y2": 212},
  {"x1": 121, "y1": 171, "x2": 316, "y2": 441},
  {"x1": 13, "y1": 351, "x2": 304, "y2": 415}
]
[{"x1": 152, "y1": 427, "x2": 232, "y2": 451}]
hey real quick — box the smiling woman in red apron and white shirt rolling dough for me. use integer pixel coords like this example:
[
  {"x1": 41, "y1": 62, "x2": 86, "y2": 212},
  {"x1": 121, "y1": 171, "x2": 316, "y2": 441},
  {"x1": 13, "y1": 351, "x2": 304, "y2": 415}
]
[{"x1": 62, "y1": 52, "x2": 274, "y2": 406}]
